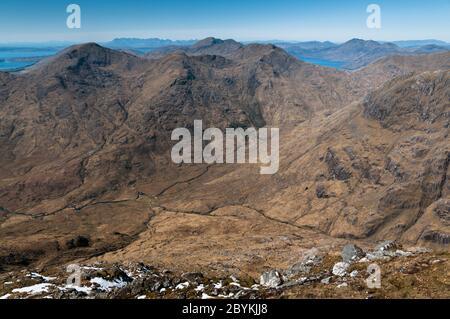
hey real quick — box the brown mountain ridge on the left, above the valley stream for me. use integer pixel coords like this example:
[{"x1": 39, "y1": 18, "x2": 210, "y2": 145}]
[{"x1": 1, "y1": 40, "x2": 370, "y2": 215}]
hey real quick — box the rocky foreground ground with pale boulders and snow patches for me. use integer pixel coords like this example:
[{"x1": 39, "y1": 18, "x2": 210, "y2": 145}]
[{"x1": 0, "y1": 247, "x2": 450, "y2": 299}]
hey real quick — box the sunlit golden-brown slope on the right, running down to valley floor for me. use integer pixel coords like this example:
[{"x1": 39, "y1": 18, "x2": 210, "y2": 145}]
[{"x1": 92, "y1": 71, "x2": 450, "y2": 272}]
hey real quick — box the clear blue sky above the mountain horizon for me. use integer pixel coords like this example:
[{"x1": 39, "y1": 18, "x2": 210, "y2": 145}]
[{"x1": 0, "y1": 0, "x2": 450, "y2": 43}]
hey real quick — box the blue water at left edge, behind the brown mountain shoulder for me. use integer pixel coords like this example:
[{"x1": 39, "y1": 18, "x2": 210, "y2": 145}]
[{"x1": 0, "y1": 47, "x2": 59, "y2": 71}]
